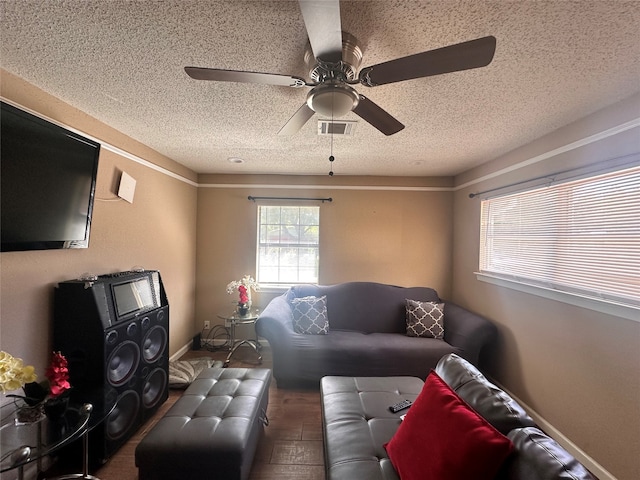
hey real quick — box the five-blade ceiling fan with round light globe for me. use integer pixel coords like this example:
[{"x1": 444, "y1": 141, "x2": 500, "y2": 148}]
[{"x1": 185, "y1": 0, "x2": 496, "y2": 135}]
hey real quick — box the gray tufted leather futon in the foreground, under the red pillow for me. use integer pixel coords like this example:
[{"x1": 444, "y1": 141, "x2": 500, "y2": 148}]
[{"x1": 321, "y1": 354, "x2": 596, "y2": 480}]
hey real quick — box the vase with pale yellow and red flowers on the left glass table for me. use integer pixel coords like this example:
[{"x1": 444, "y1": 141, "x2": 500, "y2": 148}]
[{"x1": 0, "y1": 352, "x2": 71, "y2": 423}]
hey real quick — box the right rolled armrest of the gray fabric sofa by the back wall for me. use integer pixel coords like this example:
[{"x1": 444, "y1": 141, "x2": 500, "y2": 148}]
[{"x1": 444, "y1": 302, "x2": 498, "y2": 365}]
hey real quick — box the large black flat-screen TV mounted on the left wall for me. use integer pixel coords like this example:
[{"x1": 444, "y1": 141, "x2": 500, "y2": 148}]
[{"x1": 0, "y1": 102, "x2": 100, "y2": 252}]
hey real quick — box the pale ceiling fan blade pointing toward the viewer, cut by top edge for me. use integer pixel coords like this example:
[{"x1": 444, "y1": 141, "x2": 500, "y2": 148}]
[{"x1": 299, "y1": 0, "x2": 342, "y2": 63}]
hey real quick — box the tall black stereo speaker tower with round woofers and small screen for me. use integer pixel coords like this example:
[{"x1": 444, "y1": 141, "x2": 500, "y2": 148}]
[{"x1": 53, "y1": 270, "x2": 169, "y2": 465}]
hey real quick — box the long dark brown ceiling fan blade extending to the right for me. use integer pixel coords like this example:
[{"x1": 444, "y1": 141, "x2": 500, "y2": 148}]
[{"x1": 360, "y1": 36, "x2": 496, "y2": 87}]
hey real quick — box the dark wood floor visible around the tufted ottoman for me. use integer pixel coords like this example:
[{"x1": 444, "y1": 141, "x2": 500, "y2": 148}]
[{"x1": 95, "y1": 348, "x2": 324, "y2": 480}]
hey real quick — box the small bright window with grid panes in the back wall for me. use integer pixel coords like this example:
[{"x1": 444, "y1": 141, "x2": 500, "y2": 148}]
[{"x1": 256, "y1": 205, "x2": 320, "y2": 285}]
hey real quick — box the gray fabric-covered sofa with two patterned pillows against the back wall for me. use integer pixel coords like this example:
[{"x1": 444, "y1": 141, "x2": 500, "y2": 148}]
[{"x1": 256, "y1": 282, "x2": 497, "y2": 388}]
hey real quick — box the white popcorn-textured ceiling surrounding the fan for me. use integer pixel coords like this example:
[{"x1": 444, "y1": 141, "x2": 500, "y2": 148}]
[{"x1": 0, "y1": 0, "x2": 640, "y2": 176}]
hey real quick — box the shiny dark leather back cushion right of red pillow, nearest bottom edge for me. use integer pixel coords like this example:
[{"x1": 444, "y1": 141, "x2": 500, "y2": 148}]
[{"x1": 498, "y1": 427, "x2": 595, "y2": 480}]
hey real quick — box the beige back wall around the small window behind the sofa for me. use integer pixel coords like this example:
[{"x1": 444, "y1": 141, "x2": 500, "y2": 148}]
[{"x1": 196, "y1": 175, "x2": 452, "y2": 325}]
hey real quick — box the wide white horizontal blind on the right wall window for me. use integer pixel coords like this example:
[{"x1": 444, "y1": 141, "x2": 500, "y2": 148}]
[{"x1": 480, "y1": 167, "x2": 640, "y2": 306}]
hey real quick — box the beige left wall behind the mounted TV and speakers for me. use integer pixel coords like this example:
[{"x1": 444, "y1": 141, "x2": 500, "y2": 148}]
[{"x1": 0, "y1": 71, "x2": 197, "y2": 378}]
